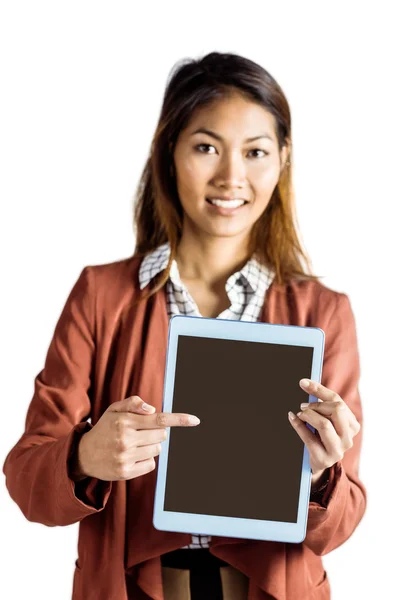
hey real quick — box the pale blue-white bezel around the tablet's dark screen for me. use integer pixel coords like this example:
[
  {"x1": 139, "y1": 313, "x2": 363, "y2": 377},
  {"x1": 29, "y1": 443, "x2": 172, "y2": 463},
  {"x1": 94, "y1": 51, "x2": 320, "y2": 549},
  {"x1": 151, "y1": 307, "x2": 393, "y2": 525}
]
[{"x1": 153, "y1": 315, "x2": 325, "y2": 543}]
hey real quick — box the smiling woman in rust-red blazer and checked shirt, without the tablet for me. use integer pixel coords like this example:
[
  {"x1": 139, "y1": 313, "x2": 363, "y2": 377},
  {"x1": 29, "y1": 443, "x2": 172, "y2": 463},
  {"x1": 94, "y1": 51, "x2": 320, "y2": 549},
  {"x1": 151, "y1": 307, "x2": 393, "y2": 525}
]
[{"x1": 4, "y1": 52, "x2": 366, "y2": 600}]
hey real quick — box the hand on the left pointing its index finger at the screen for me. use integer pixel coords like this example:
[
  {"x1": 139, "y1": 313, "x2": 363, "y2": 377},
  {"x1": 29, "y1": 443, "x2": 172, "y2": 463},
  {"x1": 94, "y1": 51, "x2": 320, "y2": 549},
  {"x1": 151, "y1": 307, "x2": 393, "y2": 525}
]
[{"x1": 72, "y1": 396, "x2": 200, "y2": 481}]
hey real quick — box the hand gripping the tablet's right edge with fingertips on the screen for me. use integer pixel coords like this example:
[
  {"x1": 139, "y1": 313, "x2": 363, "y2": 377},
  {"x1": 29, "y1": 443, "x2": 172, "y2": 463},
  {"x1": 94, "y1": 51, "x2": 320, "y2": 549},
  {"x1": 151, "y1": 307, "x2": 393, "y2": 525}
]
[{"x1": 289, "y1": 379, "x2": 361, "y2": 488}]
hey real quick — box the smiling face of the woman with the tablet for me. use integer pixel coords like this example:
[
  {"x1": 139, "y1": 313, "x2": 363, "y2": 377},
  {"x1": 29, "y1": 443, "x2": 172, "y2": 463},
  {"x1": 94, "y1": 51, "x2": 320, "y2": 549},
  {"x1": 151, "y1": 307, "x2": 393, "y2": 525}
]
[{"x1": 174, "y1": 94, "x2": 287, "y2": 243}]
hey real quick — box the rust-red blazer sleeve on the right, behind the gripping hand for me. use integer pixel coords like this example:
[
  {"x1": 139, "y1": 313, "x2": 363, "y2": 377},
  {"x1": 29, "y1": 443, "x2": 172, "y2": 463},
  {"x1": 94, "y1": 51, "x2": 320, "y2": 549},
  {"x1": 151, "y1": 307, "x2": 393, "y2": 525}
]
[{"x1": 303, "y1": 292, "x2": 367, "y2": 556}]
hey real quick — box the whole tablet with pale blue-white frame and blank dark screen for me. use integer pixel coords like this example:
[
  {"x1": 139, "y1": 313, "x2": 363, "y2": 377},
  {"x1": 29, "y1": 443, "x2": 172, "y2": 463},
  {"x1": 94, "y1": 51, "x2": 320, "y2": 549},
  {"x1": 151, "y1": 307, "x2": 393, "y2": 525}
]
[{"x1": 153, "y1": 315, "x2": 325, "y2": 543}]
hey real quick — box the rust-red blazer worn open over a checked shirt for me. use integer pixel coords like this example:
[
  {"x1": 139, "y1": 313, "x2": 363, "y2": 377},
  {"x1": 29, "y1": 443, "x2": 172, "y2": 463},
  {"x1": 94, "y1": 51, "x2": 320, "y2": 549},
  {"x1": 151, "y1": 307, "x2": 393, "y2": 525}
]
[{"x1": 3, "y1": 256, "x2": 366, "y2": 600}]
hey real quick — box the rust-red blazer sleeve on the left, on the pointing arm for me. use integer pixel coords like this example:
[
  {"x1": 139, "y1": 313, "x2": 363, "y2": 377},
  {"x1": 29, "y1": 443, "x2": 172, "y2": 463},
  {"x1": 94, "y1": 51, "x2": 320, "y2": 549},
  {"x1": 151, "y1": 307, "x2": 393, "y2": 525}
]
[{"x1": 3, "y1": 267, "x2": 112, "y2": 527}]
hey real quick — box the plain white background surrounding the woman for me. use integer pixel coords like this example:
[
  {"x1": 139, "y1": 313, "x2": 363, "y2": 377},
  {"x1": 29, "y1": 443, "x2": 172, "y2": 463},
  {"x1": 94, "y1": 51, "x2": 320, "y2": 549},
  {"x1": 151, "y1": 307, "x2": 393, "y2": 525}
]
[{"x1": 0, "y1": 0, "x2": 400, "y2": 600}]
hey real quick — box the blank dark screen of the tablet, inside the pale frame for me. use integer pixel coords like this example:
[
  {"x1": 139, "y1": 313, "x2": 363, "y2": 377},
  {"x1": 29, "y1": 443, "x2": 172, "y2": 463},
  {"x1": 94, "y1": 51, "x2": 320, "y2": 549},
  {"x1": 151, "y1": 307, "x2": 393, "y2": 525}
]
[{"x1": 164, "y1": 335, "x2": 314, "y2": 523}]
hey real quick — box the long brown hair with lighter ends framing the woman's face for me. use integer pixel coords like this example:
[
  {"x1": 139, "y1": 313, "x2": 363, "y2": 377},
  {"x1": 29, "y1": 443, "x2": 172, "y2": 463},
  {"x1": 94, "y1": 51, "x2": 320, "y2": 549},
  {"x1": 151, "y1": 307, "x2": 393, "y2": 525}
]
[{"x1": 134, "y1": 52, "x2": 318, "y2": 299}]
